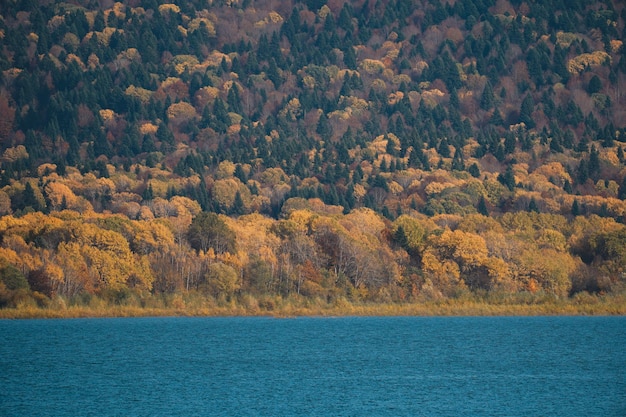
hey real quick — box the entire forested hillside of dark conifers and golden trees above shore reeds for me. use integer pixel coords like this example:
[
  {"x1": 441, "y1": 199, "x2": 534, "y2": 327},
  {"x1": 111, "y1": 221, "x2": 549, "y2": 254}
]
[{"x1": 0, "y1": 0, "x2": 626, "y2": 307}]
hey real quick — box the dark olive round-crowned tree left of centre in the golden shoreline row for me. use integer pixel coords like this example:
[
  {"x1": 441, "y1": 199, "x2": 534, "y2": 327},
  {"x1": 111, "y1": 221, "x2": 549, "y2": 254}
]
[{"x1": 187, "y1": 212, "x2": 236, "y2": 254}]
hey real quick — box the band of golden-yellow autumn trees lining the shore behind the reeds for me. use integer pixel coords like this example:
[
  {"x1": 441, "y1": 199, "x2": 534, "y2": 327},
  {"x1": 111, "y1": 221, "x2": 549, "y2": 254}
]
[{"x1": 0, "y1": 197, "x2": 626, "y2": 307}]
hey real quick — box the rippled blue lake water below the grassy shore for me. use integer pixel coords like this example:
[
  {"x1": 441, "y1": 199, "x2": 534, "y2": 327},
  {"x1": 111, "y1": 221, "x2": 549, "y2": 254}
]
[{"x1": 0, "y1": 317, "x2": 626, "y2": 417}]
